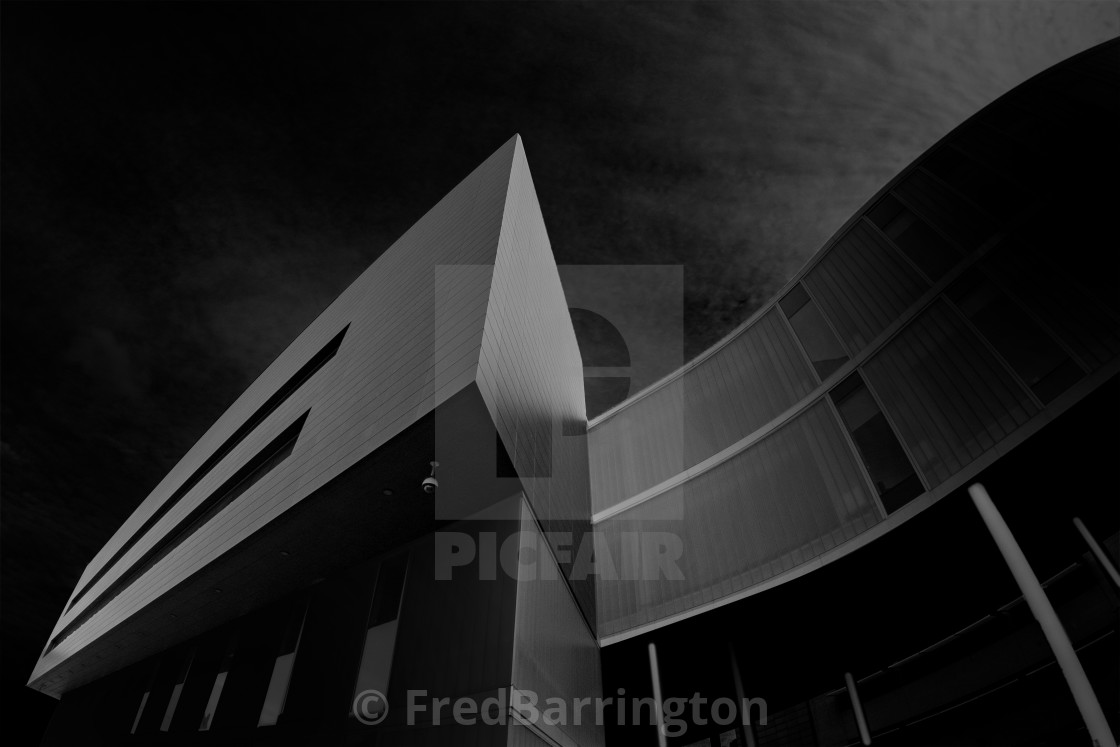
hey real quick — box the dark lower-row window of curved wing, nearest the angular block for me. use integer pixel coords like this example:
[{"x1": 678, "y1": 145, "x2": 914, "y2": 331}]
[{"x1": 831, "y1": 373, "x2": 924, "y2": 513}]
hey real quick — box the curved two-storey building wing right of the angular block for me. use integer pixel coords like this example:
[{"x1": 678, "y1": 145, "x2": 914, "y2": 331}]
[{"x1": 588, "y1": 36, "x2": 1120, "y2": 643}]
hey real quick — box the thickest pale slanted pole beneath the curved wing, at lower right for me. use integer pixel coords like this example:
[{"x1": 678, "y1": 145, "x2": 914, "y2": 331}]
[{"x1": 969, "y1": 483, "x2": 1117, "y2": 747}]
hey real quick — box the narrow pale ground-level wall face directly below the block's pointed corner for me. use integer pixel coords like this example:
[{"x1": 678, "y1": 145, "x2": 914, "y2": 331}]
[{"x1": 513, "y1": 504, "x2": 605, "y2": 746}]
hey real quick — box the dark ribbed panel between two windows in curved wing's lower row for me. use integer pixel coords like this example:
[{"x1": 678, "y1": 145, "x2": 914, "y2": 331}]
[{"x1": 864, "y1": 299, "x2": 1038, "y2": 487}]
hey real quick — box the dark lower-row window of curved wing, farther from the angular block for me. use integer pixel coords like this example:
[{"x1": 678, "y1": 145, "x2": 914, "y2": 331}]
[{"x1": 949, "y1": 270, "x2": 1083, "y2": 402}]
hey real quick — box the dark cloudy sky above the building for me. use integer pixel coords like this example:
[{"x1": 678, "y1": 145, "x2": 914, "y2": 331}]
[{"x1": 0, "y1": 1, "x2": 1120, "y2": 734}]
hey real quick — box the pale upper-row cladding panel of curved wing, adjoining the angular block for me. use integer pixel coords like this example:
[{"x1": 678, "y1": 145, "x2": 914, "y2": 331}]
[{"x1": 589, "y1": 309, "x2": 815, "y2": 512}]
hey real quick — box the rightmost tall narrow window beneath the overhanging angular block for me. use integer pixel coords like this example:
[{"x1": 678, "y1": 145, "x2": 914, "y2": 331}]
[{"x1": 352, "y1": 554, "x2": 408, "y2": 717}]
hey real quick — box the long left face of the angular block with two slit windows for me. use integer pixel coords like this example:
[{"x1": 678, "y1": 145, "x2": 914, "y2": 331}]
[{"x1": 31, "y1": 140, "x2": 515, "y2": 694}]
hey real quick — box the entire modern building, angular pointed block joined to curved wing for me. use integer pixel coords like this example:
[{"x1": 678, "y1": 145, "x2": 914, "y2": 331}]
[{"x1": 29, "y1": 41, "x2": 1120, "y2": 747}]
